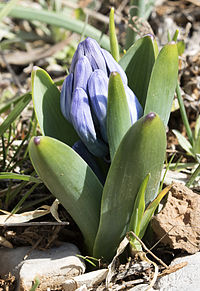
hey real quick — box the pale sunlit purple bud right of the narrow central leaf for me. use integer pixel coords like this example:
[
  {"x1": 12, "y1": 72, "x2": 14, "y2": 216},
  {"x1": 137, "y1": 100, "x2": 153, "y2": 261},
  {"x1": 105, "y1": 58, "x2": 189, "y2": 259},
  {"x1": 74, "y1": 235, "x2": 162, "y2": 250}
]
[{"x1": 124, "y1": 86, "x2": 143, "y2": 124}]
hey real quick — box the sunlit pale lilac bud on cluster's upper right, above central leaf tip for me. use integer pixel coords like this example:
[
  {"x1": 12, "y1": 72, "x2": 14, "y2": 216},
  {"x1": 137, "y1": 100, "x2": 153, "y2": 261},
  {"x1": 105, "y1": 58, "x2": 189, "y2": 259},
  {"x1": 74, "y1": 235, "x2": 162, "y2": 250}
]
[{"x1": 101, "y1": 49, "x2": 127, "y2": 85}]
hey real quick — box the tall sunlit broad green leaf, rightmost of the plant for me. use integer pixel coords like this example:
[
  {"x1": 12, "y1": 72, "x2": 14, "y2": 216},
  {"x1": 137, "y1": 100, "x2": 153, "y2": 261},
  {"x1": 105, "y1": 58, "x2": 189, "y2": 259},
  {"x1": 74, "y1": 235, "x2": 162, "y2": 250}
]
[{"x1": 144, "y1": 42, "x2": 178, "y2": 126}]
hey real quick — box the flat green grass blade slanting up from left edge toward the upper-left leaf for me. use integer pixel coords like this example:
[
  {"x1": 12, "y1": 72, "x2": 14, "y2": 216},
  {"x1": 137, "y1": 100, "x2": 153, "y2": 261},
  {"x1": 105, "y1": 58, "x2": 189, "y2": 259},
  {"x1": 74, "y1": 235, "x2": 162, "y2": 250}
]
[{"x1": 0, "y1": 93, "x2": 31, "y2": 136}]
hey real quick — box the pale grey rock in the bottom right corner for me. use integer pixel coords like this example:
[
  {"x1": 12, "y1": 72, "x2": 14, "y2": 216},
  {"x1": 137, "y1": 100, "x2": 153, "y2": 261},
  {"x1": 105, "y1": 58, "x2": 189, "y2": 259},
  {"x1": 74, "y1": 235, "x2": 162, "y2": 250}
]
[{"x1": 154, "y1": 252, "x2": 200, "y2": 291}]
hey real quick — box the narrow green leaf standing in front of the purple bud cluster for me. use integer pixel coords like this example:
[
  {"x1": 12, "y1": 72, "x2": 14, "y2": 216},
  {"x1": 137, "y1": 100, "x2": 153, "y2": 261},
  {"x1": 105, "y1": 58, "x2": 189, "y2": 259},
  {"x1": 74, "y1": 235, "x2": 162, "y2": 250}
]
[{"x1": 106, "y1": 72, "x2": 131, "y2": 160}]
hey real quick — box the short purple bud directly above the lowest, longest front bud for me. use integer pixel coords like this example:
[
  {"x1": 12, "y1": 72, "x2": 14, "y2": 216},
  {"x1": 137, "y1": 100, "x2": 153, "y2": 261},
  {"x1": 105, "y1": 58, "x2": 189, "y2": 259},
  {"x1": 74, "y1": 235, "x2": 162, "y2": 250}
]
[{"x1": 74, "y1": 56, "x2": 92, "y2": 91}]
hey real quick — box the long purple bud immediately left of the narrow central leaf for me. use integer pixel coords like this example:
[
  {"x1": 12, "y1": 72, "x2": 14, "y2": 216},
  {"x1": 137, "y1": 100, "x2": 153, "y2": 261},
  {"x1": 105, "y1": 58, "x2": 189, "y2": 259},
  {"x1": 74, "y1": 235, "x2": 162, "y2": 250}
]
[{"x1": 88, "y1": 70, "x2": 109, "y2": 142}]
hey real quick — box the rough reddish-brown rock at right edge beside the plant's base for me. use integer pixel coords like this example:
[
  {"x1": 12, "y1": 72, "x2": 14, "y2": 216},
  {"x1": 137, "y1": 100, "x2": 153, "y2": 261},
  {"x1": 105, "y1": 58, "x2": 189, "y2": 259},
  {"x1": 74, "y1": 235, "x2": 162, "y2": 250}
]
[{"x1": 152, "y1": 183, "x2": 200, "y2": 254}]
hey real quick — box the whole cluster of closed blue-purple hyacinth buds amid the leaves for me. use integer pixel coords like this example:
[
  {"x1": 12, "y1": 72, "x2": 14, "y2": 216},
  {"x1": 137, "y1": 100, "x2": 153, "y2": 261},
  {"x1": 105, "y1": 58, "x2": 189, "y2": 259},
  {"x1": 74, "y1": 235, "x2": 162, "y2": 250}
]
[{"x1": 60, "y1": 37, "x2": 142, "y2": 157}]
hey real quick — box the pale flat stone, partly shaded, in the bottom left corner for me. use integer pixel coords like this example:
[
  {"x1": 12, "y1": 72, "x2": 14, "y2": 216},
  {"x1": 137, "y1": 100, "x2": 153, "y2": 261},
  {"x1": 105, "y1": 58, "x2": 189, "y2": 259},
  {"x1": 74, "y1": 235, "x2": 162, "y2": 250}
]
[{"x1": 0, "y1": 243, "x2": 85, "y2": 291}]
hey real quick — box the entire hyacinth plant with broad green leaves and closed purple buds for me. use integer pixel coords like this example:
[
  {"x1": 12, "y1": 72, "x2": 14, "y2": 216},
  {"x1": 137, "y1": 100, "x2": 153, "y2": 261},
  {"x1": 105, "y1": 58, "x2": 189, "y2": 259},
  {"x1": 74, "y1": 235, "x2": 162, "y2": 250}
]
[{"x1": 29, "y1": 10, "x2": 178, "y2": 261}]
